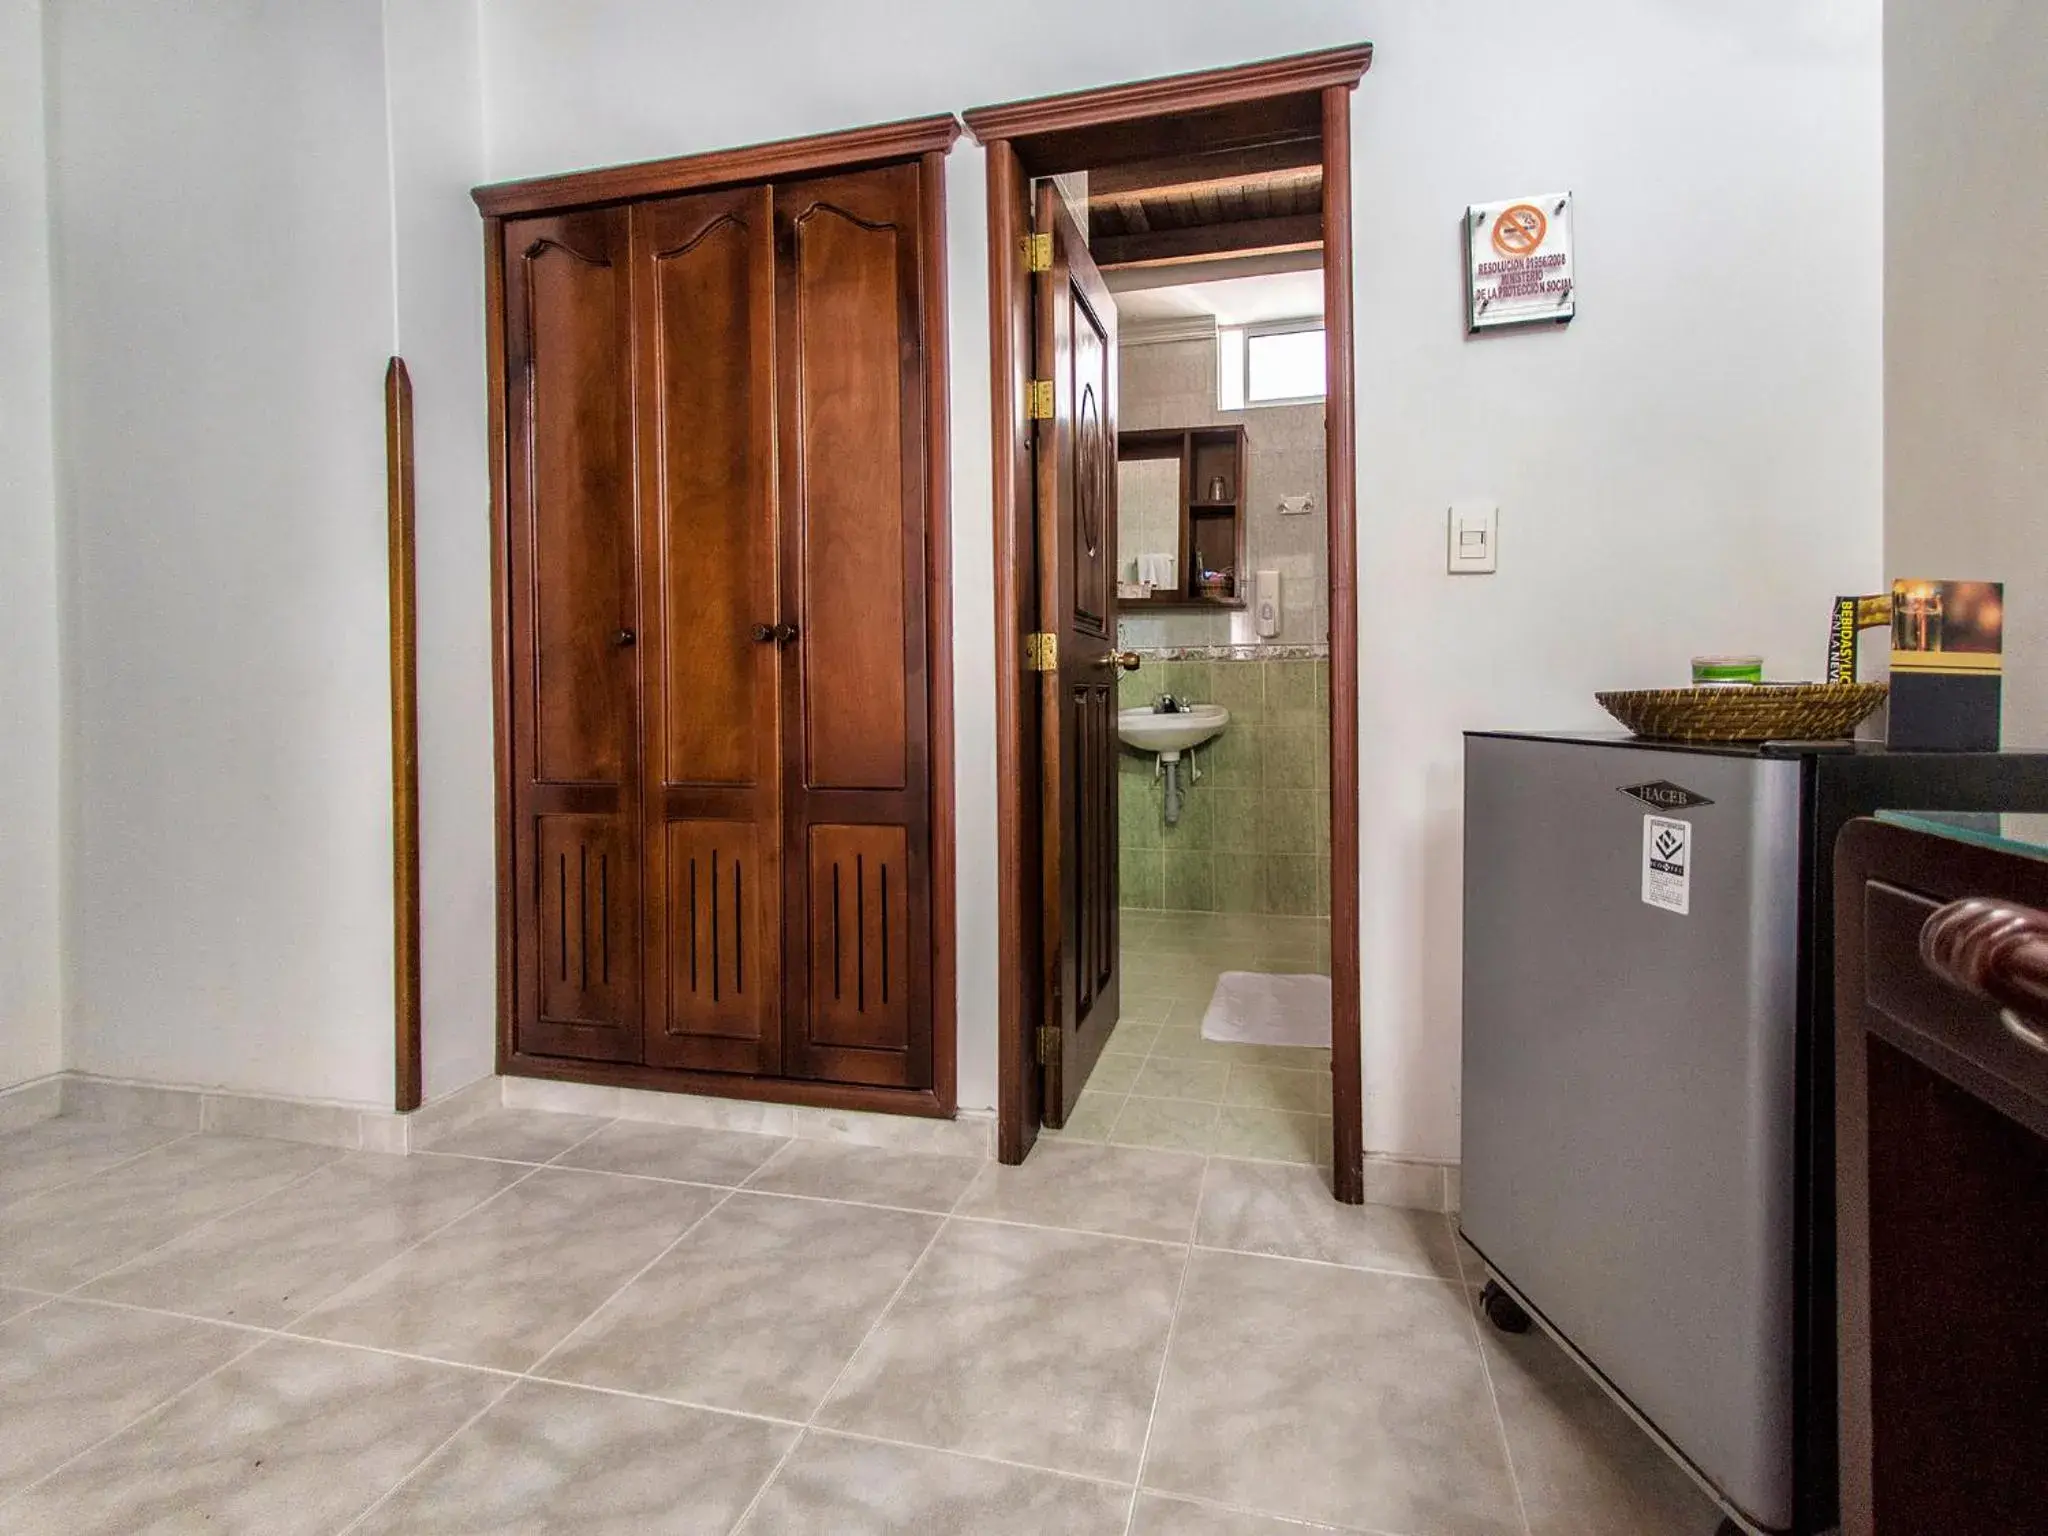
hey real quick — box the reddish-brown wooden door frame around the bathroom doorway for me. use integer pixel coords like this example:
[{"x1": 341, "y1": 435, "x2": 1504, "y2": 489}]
[{"x1": 965, "y1": 43, "x2": 1372, "y2": 1204}]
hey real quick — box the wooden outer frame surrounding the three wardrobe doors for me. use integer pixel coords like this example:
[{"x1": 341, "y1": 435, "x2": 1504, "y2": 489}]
[{"x1": 471, "y1": 113, "x2": 961, "y2": 1118}]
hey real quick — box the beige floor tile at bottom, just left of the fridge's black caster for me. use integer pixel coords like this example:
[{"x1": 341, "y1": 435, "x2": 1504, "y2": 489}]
[{"x1": 1143, "y1": 1249, "x2": 1522, "y2": 1536}]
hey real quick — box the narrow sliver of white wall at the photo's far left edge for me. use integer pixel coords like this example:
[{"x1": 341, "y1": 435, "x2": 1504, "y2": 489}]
[{"x1": 0, "y1": 0, "x2": 63, "y2": 1087}]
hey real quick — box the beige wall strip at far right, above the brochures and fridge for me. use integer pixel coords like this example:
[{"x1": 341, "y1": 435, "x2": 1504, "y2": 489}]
[{"x1": 1884, "y1": 0, "x2": 2048, "y2": 748}]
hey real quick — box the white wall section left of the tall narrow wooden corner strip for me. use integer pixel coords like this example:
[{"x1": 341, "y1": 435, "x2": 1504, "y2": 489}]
[{"x1": 47, "y1": 0, "x2": 401, "y2": 1106}]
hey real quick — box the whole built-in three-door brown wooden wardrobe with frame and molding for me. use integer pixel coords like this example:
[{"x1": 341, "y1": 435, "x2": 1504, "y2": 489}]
[{"x1": 477, "y1": 119, "x2": 956, "y2": 1114}]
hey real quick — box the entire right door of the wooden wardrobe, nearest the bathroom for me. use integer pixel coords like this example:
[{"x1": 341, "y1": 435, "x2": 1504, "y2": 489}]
[{"x1": 774, "y1": 164, "x2": 932, "y2": 1087}]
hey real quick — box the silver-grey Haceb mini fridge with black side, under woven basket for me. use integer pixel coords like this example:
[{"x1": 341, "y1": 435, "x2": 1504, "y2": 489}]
[{"x1": 1460, "y1": 733, "x2": 2048, "y2": 1536}]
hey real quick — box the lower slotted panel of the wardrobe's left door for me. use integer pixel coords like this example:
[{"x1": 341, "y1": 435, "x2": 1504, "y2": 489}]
[{"x1": 520, "y1": 815, "x2": 641, "y2": 1061}]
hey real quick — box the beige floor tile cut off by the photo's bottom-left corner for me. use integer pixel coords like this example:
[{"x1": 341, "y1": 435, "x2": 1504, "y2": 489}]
[{"x1": 0, "y1": 1339, "x2": 506, "y2": 1536}]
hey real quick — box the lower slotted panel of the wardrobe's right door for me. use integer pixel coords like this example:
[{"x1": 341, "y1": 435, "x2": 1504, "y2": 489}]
[{"x1": 809, "y1": 825, "x2": 911, "y2": 1051}]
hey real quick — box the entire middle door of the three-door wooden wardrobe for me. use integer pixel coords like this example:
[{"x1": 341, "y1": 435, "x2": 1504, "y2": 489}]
[{"x1": 633, "y1": 186, "x2": 782, "y2": 1073}]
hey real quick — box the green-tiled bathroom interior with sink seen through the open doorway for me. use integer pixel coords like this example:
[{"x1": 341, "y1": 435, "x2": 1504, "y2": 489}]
[{"x1": 1059, "y1": 259, "x2": 1331, "y2": 1167}]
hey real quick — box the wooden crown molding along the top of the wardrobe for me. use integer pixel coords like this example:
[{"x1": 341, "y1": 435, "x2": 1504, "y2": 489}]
[{"x1": 471, "y1": 113, "x2": 961, "y2": 219}]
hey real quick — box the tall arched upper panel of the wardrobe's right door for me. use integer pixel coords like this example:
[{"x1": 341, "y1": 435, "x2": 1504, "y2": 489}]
[{"x1": 776, "y1": 166, "x2": 924, "y2": 791}]
